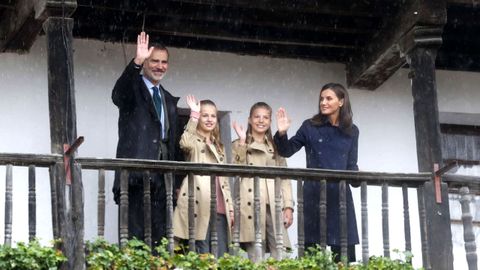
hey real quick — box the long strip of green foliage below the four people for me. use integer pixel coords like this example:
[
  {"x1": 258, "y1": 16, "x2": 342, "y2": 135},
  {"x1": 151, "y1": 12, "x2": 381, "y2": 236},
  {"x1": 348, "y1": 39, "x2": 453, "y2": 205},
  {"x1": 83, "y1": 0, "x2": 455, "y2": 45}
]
[{"x1": 87, "y1": 239, "x2": 422, "y2": 270}]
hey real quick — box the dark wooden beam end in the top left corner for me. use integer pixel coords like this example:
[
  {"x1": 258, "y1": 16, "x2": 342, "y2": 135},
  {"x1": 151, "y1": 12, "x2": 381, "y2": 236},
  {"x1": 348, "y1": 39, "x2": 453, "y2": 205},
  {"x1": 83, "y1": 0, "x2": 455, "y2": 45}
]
[{"x1": 0, "y1": 0, "x2": 76, "y2": 53}]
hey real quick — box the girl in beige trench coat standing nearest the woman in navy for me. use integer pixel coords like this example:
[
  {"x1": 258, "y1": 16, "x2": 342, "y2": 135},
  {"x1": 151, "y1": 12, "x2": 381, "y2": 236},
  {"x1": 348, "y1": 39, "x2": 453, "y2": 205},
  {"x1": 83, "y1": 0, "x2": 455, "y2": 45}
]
[{"x1": 232, "y1": 102, "x2": 293, "y2": 261}]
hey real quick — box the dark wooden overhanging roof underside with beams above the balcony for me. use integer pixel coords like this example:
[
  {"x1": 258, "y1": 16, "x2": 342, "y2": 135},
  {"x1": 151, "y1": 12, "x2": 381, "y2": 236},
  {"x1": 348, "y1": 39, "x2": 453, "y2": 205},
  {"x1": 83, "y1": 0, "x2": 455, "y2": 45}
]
[{"x1": 0, "y1": 0, "x2": 480, "y2": 89}]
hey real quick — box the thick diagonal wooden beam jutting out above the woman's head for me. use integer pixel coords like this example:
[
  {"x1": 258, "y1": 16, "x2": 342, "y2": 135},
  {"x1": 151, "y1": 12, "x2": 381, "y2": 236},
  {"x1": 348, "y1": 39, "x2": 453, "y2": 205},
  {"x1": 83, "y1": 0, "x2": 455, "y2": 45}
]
[{"x1": 346, "y1": 0, "x2": 446, "y2": 90}]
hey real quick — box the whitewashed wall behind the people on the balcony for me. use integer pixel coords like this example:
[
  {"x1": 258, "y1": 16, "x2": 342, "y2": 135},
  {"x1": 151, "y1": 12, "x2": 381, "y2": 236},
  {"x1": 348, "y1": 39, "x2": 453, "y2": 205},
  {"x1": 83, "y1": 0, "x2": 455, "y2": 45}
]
[{"x1": 0, "y1": 37, "x2": 480, "y2": 269}]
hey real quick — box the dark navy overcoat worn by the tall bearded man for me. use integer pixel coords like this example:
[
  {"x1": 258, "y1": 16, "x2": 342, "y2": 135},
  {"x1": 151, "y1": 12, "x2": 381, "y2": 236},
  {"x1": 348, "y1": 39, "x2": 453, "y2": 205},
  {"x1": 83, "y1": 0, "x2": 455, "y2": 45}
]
[{"x1": 112, "y1": 60, "x2": 179, "y2": 245}]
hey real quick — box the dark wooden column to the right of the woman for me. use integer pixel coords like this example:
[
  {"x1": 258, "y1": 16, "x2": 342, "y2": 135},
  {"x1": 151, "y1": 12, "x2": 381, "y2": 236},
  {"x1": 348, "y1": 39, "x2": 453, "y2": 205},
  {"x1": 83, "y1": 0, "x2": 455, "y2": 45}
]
[{"x1": 409, "y1": 27, "x2": 453, "y2": 270}]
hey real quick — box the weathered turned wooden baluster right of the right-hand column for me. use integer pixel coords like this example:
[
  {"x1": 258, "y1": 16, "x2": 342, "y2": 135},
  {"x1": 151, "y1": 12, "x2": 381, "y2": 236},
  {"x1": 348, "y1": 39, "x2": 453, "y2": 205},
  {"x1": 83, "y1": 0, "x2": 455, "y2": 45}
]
[{"x1": 460, "y1": 186, "x2": 477, "y2": 270}]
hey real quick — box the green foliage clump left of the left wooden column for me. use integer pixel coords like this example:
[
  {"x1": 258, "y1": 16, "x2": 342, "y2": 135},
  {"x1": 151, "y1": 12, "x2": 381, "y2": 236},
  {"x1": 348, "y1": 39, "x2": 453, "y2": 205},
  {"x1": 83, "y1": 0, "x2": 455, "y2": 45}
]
[{"x1": 0, "y1": 240, "x2": 67, "y2": 270}]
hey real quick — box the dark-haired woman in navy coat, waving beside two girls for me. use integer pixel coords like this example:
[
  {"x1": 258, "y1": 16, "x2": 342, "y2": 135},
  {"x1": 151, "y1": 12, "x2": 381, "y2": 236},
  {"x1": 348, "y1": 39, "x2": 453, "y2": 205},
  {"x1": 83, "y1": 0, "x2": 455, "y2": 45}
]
[{"x1": 274, "y1": 83, "x2": 359, "y2": 261}]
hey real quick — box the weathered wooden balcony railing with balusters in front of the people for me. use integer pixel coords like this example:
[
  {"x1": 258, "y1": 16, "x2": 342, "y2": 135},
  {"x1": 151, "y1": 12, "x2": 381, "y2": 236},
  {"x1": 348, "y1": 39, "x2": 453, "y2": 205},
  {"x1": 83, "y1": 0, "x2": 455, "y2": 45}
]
[{"x1": 0, "y1": 154, "x2": 480, "y2": 269}]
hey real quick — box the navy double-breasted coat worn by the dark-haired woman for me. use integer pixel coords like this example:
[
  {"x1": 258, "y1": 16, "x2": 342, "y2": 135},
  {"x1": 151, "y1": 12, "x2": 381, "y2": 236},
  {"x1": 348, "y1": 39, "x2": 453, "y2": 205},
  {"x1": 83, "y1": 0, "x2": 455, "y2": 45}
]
[{"x1": 274, "y1": 119, "x2": 359, "y2": 246}]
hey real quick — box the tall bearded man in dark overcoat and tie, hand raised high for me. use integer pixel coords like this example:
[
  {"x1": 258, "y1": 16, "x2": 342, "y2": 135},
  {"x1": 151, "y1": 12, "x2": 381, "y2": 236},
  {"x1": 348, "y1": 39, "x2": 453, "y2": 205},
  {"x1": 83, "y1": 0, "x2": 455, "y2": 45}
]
[{"x1": 112, "y1": 32, "x2": 179, "y2": 245}]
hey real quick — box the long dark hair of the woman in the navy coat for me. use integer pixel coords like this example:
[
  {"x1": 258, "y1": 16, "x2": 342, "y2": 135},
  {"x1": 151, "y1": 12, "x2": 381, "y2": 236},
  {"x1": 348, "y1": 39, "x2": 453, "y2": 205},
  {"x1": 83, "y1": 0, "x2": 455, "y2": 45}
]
[{"x1": 310, "y1": 83, "x2": 353, "y2": 135}]
